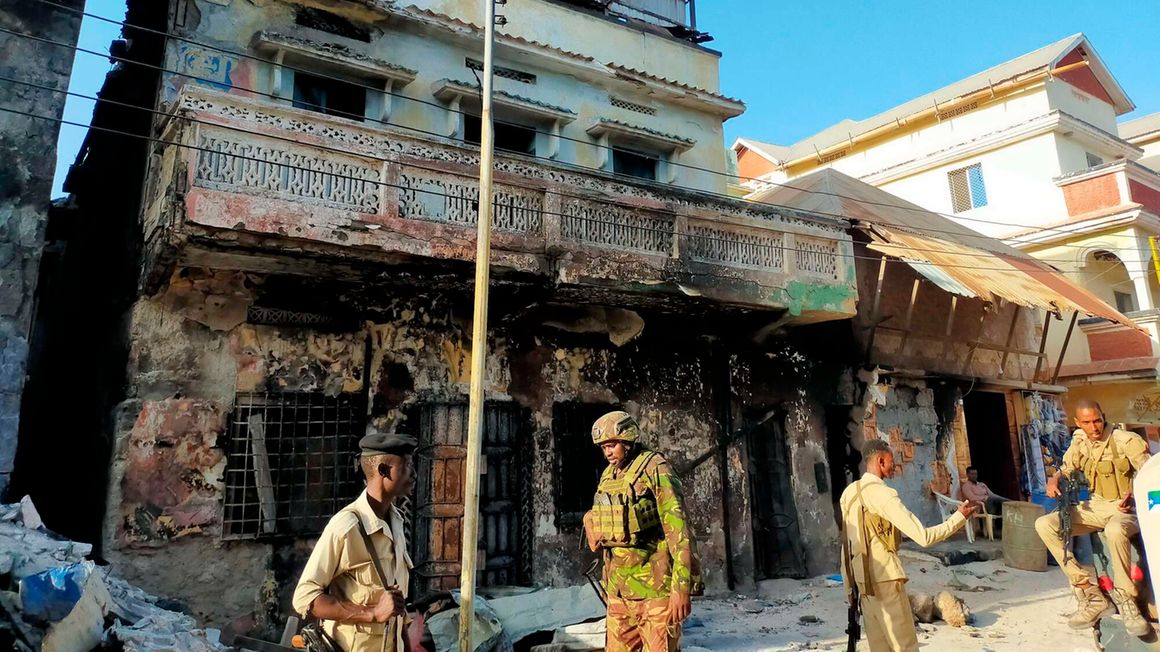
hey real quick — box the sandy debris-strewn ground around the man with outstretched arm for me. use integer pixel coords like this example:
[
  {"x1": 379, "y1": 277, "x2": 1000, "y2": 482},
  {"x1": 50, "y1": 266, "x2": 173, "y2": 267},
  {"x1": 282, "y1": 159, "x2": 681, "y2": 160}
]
[{"x1": 682, "y1": 542, "x2": 1096, "y2": 652}]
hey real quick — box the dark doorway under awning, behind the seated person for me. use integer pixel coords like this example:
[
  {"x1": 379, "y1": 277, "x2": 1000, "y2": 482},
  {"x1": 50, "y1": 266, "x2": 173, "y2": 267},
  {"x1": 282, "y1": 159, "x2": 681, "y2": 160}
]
[{"x1": 963, "y1": 391, "x2": 1020, "y2": 499}]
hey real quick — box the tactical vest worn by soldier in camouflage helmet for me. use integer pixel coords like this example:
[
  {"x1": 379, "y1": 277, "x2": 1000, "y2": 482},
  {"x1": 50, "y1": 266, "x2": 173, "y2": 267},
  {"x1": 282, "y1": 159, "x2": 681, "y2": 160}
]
[{"x1": 592, "y1": 450, "x2": 660, "y2": 548}]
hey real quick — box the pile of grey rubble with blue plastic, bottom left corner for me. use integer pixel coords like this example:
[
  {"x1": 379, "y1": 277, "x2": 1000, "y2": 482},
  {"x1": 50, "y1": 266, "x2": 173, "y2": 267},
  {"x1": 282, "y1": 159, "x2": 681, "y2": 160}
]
[{"x1": 0, "y1": 498, "x2": 226, "y2": 652}]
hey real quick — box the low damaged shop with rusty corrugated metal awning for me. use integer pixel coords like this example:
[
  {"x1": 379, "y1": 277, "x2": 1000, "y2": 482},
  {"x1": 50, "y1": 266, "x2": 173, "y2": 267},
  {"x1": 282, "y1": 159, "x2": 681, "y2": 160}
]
[{"x1": 749, "y1": 168, "x2": 1138, "y2": 523}]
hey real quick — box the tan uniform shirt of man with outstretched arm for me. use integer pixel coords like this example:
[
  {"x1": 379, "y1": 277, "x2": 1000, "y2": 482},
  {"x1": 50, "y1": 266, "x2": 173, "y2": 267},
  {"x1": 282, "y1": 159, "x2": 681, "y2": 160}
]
[{"x1": 839, "y1": 473, "x2": 966, "y2": 586}]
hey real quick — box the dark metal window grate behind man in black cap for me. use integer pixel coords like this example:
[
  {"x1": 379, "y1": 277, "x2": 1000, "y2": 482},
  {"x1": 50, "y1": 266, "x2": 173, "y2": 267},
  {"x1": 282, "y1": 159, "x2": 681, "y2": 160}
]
[{"x1": 222, "y1": 392, "x2": 367, "y2": 539}]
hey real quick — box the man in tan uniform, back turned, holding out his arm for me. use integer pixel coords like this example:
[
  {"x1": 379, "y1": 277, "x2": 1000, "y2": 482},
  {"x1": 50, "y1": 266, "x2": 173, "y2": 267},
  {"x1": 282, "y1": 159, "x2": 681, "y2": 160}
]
[{"x1": 839, "y1": 440, "x2": 978, "y2": 652}]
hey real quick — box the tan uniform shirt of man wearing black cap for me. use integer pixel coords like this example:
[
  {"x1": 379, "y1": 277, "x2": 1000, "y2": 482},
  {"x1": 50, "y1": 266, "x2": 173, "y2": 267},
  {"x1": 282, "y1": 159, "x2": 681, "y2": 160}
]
[{"x1": 292, "y1": 491, "x2": 412, "y2": 652}]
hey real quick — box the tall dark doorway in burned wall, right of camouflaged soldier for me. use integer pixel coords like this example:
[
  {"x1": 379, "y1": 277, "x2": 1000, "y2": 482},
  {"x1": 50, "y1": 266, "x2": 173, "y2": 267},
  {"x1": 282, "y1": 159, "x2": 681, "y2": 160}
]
[{"x1": 746, "y1": 414, "x2": 805, "y2": 580}]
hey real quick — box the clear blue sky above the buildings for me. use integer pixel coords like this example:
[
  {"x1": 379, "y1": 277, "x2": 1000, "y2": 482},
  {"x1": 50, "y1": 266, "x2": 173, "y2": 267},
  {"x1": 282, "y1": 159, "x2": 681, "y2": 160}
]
[{"x1": 53, "y1": 0, "x2": 1160, "y2": 196}]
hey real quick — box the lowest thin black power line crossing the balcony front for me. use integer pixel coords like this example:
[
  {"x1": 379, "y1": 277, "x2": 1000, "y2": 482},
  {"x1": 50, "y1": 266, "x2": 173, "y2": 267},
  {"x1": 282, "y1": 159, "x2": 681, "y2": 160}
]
[{"x1": 0, "y1": 100, "x2": 1113, "y2": 274}]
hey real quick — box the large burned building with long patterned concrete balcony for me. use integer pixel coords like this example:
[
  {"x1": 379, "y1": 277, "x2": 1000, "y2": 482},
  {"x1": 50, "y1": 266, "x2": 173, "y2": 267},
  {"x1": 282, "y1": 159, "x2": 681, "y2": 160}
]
[{"x1": 21, "y1": 0, "x2": 872, "y2": 631}]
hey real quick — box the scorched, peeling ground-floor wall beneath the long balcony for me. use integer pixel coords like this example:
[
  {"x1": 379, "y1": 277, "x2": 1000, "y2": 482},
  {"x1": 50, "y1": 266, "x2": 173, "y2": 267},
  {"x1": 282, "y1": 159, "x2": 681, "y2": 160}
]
[{"x1": 104, "y1": 268, "x2": 836, "y2": 629}]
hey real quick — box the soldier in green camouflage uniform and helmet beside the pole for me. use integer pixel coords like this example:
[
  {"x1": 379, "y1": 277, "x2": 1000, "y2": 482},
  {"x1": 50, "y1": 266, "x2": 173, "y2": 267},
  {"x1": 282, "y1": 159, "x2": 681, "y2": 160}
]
[{"x1": 583, "y1": 412, "x2": 697, "y2": 652}]
